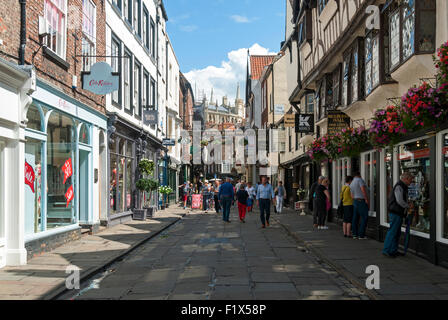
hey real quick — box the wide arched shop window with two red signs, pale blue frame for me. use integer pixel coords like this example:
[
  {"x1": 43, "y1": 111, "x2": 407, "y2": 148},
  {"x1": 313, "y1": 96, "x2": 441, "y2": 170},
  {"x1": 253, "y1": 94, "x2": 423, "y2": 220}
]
[{"x1": 46, "y1": 111, "x2": 77, "y2": 229}]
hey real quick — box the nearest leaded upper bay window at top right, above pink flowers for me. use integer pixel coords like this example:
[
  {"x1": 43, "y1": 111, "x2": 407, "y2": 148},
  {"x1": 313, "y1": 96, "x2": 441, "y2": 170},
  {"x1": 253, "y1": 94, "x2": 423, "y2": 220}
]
[{"x1": 387, "y1": 0, "x2": 436, "y2": 69}]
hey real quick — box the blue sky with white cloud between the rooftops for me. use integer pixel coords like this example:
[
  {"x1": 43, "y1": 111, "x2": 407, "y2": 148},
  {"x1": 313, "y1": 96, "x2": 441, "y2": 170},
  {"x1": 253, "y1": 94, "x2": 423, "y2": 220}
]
[{"x1": 164, "y1": 0, "x2": 286, "y2": 103}]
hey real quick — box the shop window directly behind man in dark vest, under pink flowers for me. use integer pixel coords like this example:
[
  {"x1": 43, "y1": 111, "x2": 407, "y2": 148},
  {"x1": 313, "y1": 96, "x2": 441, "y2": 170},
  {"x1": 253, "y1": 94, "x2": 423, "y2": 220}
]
[{"x1": 398, "y1": 140, "x2": 431, "y2": 233}]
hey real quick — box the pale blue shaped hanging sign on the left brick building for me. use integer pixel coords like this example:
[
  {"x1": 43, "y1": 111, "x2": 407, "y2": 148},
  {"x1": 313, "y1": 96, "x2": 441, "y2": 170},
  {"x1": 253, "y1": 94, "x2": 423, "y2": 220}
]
[{"x1": 82, "y1": 62, "x2": 120, "y2": 95}]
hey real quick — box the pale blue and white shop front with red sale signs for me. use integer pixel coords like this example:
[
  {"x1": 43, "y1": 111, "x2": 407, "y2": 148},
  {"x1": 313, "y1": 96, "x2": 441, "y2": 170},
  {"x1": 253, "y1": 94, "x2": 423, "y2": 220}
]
[{"x1": 24, "y1": 81, "x2": 107, "y2": 257}]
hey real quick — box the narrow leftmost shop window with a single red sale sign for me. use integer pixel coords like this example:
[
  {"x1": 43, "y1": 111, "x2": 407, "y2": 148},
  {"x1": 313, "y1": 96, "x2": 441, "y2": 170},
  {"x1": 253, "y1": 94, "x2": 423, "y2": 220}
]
[{"x1": 25, "y1": 137, "x2": 43, "y2": 234}]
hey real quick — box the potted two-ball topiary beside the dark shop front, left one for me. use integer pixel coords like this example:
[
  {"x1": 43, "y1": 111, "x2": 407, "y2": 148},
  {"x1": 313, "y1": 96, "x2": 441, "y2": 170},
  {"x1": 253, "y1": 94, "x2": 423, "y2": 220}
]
[{"x1": 133, "y1": 159, "x2": 159, "y2": 220}]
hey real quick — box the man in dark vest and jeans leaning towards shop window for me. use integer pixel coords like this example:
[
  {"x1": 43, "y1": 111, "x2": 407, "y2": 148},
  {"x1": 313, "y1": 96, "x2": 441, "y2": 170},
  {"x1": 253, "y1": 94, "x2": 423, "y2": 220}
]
[{"x1": 383, "y1": 172, "x2": 414, "y2": 258}]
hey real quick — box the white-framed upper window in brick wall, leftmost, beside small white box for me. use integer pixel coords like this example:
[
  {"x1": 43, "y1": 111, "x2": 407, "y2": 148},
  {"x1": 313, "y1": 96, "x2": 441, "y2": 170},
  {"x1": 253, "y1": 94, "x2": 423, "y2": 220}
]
[{"x1": 44, "y1": 0, "x2": 67, "y2": 59}]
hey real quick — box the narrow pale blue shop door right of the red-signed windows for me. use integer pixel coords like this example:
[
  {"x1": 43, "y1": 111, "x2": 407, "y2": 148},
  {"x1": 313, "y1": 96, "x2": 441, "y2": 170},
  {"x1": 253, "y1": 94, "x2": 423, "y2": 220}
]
[{"x1": 78, "y1": 150, "x2": 90, "y2": 223}]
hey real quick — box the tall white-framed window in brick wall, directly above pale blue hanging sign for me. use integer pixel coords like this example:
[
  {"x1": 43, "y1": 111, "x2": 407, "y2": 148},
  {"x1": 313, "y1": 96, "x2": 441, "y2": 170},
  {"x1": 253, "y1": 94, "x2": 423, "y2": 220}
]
[{"x1": 82, "y1": 0, "x2": 96, "y2": 71}]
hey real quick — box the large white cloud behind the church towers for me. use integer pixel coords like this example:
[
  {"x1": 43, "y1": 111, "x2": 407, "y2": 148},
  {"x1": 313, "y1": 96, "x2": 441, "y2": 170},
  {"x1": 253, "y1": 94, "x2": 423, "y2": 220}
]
[{"x1": 185, "y1": 43, "x2": 276, "y2": 104}]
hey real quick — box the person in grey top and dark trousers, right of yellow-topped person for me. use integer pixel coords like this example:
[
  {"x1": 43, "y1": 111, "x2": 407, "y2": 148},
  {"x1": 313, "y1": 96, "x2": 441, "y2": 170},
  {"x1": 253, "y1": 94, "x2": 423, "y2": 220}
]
[{"x1": 350, "y1": 172, "x2": 370, "y2": 240}]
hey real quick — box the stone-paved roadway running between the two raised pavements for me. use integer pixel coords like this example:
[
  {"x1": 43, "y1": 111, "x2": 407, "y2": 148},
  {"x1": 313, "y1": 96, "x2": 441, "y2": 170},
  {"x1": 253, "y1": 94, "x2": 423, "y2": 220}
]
[{"x1": 60, "y1": 207, "x2": 368, "y2": 300}]
